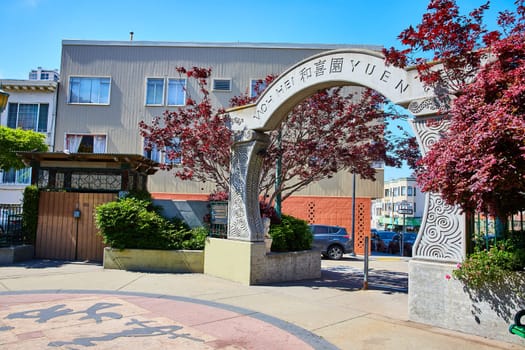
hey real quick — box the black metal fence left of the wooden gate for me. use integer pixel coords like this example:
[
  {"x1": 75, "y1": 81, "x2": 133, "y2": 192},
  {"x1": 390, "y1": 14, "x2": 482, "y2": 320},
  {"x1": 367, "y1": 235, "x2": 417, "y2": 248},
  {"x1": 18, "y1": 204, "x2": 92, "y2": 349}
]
[{"x1": 0, "y1": 204, "x2": 25, "y2": 247}]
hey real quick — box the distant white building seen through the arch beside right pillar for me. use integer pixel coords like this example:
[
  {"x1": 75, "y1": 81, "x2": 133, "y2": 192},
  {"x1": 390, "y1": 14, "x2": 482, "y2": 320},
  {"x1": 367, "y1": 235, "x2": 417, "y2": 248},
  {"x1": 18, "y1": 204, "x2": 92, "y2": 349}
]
[{"x1": 371, "y1": 177, "x2": 425, "y2": 232}]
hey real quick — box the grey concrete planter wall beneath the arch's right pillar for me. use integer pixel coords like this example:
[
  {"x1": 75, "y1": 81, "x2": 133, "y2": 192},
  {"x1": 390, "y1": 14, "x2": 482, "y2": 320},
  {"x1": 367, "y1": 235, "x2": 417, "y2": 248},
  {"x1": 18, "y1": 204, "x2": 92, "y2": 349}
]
[{"x1": 408, "y1": 260, "x2": 525, "y2": 346}]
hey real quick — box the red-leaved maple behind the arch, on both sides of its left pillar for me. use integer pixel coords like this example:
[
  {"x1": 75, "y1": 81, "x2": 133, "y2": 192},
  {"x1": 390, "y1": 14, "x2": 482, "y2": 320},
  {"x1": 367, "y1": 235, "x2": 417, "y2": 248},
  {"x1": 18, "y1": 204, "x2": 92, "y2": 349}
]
[{"x1": 140, "y1": 67, "x2": 400, "y2": 208}]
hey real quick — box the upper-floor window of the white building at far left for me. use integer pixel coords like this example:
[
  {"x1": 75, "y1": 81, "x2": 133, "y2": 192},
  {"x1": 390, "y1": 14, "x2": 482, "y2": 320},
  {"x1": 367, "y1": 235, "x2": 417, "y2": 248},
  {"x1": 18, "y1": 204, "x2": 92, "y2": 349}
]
[{"x1": 7, "y1": 103, "x2": 49, "y2": 132}]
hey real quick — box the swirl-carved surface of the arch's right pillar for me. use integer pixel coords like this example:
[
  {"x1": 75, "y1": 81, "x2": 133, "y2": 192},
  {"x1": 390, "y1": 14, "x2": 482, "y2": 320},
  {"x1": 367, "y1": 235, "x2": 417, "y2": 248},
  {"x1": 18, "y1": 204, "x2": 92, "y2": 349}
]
[{"x1": 411, "y1": 118, "x2": 465, "y2": 262}]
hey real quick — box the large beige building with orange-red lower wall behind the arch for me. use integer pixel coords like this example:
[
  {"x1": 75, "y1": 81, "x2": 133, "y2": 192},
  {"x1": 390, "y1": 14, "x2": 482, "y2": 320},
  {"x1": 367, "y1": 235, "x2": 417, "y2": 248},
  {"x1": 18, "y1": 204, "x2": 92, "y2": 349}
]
[{"x1": 54, "y1": 40, "x2": 383, "y2": 250}]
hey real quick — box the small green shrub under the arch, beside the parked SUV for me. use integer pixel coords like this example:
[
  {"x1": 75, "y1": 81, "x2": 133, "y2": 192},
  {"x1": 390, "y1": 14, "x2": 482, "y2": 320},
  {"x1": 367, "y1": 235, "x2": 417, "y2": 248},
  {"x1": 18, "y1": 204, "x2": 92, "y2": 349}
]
[{"x1": 269, "y1": 215, "x2": 313, "y2": 252}]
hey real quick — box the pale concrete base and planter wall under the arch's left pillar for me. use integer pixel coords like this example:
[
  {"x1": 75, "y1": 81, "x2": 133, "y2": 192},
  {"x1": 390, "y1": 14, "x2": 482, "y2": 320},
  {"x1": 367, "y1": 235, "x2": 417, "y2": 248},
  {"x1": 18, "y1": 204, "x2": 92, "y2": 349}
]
[{"x1": 204, "y1": 238, "x2": 321, "y2": 285}]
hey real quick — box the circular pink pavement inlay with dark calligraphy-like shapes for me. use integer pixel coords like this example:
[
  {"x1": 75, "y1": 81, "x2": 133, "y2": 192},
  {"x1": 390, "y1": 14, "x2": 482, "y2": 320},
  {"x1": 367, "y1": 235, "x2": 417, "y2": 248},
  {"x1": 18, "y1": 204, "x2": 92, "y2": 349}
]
[{"x1": 0, "y1": 291, "x2": 336, "y2": 350}]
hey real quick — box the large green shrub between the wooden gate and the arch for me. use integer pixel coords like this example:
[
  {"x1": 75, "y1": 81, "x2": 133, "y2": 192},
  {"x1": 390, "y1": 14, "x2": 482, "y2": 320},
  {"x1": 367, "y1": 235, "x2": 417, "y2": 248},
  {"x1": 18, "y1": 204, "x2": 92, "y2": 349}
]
[{"x1": 95, "y1": 197, "x2": 206, "y2": 250}]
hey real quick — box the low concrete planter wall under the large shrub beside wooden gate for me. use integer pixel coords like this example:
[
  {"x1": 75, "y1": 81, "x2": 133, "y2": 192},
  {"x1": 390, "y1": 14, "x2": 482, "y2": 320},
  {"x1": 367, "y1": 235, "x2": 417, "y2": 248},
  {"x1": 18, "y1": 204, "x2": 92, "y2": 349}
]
[{"x1": 104, "y1": 247, "x2": 204, "y2": 273}]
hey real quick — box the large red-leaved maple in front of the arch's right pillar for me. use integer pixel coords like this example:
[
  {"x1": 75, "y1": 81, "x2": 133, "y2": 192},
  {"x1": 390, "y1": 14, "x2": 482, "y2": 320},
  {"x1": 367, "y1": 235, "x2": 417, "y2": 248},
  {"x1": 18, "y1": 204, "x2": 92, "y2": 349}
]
[{"x1": 384, "y1": 0, "x2": 525, "y2": 219}]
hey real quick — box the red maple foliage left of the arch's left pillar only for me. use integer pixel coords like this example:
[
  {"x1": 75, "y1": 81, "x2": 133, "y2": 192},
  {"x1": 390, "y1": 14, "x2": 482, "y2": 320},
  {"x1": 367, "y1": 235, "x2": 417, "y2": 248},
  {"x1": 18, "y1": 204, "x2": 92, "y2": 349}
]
[{"x1": 139, "y1": 67, "x2": 231, "y2": 191}]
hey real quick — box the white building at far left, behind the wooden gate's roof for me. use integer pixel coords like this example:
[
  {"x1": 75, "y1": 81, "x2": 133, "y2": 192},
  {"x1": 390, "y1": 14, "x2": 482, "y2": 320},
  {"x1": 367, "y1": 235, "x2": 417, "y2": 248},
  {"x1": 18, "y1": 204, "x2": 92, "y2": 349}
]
[{"x1": 0, "y1": 67, "x2": 60, "y2": 204}]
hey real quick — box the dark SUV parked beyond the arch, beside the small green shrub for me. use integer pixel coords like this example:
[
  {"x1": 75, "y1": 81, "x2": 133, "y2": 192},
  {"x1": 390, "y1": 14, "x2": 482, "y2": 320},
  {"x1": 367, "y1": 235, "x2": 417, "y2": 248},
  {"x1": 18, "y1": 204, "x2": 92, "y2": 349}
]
[{"x1": 310, "y1": 224, "x2": 354, "y2": 260}]
